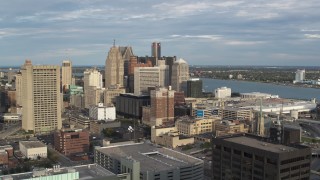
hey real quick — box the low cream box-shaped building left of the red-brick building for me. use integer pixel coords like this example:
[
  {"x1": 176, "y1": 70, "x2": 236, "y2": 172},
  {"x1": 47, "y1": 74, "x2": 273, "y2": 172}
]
[{"x1": 19, "y1": 141, "x2": 47, "y2": 159}]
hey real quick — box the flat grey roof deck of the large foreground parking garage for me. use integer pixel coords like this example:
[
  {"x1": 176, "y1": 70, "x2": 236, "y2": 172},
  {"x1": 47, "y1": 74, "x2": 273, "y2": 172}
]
[{"x1": 97, "y1": 143, "x2": 203, "y2": 172}]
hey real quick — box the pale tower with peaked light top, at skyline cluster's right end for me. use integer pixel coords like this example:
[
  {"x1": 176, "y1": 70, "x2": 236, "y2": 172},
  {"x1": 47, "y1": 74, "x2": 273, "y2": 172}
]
[{"x1": 171, "y1": 59, "x2": 189, "y2": 92}]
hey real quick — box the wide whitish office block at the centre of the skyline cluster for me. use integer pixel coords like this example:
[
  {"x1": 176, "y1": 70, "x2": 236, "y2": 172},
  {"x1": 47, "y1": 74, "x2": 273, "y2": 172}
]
[{"x1": 134, "y1": 60, "x2": 169, "y2": 95}]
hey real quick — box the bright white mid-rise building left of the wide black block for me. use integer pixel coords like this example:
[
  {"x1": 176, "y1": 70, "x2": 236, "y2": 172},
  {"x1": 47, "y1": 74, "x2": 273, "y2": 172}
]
[{"x1": 89, "y1": 103, "x2": 116, "y2": 121}]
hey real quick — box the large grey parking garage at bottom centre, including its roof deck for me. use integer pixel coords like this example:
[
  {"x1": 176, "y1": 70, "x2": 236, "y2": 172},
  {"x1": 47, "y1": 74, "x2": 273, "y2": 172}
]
[{"x1": 94, "y1": 143, "x2": 204, "y2": 180}]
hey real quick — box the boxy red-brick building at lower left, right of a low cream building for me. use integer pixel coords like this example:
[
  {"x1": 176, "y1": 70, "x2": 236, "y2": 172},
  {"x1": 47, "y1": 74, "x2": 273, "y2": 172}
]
[{"x1": 54, "y1": 129, "x2": 90, "y2": 156}]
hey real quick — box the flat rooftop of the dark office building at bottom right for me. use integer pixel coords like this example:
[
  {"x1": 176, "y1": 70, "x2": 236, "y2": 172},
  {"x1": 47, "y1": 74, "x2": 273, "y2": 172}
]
[{"x1": 224, "y1": 134, "x2": 303, "y2": 153}]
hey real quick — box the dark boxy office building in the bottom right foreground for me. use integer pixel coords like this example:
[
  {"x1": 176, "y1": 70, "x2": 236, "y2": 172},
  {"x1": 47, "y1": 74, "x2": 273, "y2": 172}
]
[{"x1": 212, "y1": 134, "x2": 311, "y2": 180}]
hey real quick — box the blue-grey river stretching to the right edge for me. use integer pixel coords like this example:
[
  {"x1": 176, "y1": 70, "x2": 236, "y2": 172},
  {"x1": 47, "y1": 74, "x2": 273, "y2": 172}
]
[{"x1": 201, "y1": 78, "x2": 320, "y2": 101}]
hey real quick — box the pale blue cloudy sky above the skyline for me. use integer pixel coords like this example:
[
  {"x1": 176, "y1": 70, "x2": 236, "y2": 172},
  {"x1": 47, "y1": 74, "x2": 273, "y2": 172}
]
[{"x1": 0, "y1": 0, "x2": 320, "y2": 66}]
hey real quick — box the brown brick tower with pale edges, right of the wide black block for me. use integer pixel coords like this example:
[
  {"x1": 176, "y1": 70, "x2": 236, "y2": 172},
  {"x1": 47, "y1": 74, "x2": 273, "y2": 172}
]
[{"x1": 150, "y1": 87, "x2": 174, "y2": 126}]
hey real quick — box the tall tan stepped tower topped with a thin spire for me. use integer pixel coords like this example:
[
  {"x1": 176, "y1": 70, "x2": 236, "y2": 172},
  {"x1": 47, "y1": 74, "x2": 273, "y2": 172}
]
[{"x1": 105, "y1": 46, "x2": 124, "y2": 88}]
